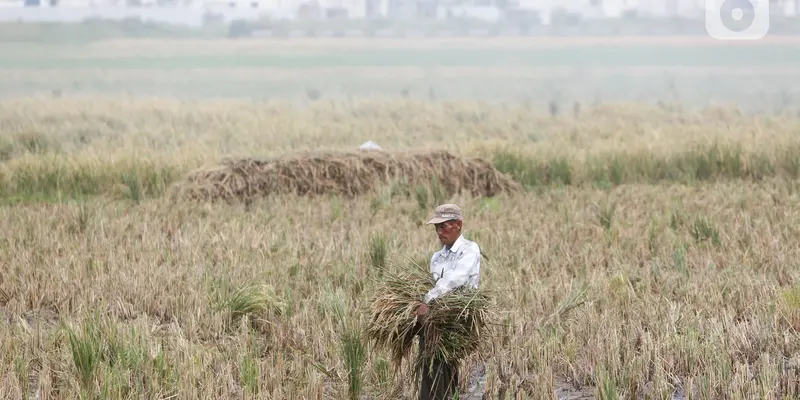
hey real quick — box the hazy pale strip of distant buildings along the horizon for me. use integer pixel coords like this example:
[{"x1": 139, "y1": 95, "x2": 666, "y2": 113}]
[{"x1": 0, "y1": 0, "x2": 800, "y2": 25}]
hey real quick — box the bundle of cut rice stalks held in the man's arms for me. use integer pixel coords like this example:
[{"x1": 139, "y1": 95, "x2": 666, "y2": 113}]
[{"x1": 367, "y1": 262, "x2": 492, "y2": 370}]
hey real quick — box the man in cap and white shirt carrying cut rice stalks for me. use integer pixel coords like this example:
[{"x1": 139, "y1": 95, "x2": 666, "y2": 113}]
[{"x1": 417, "y1": 204, "x2": 481, "y2": 400}]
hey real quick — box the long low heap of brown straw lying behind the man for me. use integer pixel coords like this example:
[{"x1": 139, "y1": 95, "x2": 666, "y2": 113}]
[{"x1": 173, "y1": 152, "x2": 521, "y2": 201}]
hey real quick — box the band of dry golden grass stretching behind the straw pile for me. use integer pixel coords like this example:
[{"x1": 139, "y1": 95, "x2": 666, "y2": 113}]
[{"x1": 0, "y1": 97, "x2": 800, "y2": 160}]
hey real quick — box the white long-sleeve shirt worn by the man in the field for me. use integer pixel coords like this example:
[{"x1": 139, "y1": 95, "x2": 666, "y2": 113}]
[{"x1": 423, "y1": 236, "x2": 481, "y2": 304}]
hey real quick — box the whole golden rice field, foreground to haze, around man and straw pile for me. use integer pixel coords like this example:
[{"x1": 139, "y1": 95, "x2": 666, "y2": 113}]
[{"x1": 0, "y1": 36, "x2": 800, "y2": 399}]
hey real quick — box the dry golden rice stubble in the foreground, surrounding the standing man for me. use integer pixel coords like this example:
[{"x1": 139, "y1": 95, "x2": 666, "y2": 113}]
[{"x1": 0, "y1": 182, "x2": 800, "y2": 398}]
